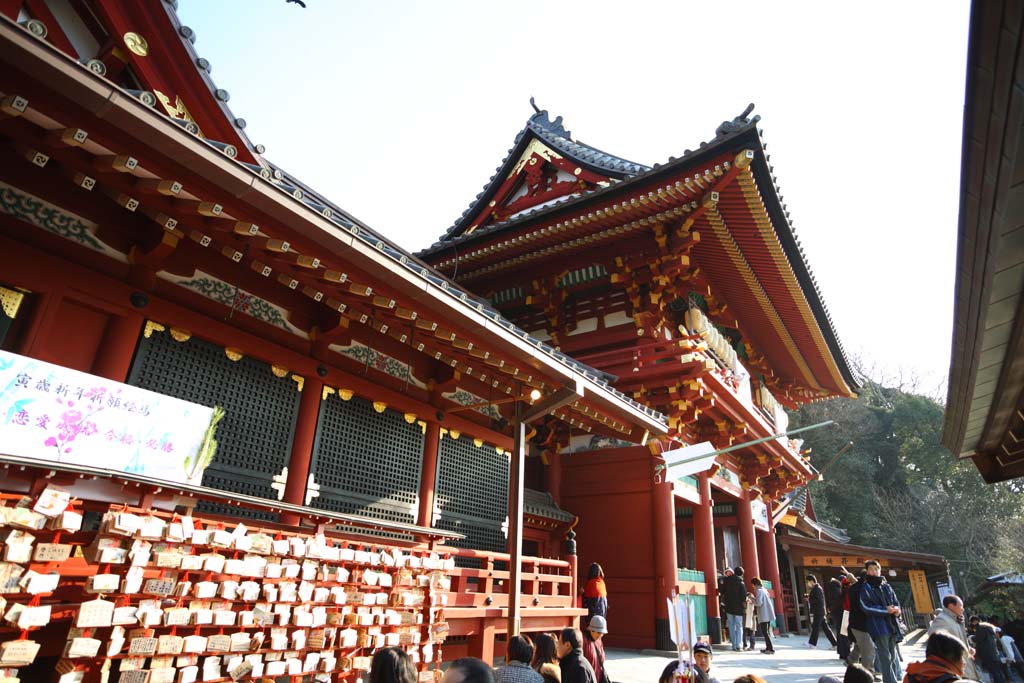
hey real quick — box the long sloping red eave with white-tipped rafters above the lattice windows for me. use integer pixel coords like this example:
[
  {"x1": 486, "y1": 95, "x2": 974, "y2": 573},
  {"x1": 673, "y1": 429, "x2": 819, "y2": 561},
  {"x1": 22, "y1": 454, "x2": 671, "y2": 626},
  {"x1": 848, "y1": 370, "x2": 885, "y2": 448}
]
[{"x1": 0, "y1": 20, "x2": 666, "y2": 438}]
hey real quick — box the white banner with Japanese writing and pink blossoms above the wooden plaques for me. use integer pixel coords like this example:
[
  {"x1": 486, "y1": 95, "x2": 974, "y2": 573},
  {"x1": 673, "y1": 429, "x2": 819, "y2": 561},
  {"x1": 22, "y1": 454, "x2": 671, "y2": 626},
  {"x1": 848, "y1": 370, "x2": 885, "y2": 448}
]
[{"x1": 0, "y1": 351, "x2": 213, "y2": 485}]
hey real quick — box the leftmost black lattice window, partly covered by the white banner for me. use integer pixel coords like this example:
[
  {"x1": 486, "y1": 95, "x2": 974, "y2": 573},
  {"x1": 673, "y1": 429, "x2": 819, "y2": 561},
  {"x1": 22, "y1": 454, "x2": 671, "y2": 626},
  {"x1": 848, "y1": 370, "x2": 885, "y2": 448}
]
[{"x1": 128, "y1": 332, "x2": 302, "y2": 519}]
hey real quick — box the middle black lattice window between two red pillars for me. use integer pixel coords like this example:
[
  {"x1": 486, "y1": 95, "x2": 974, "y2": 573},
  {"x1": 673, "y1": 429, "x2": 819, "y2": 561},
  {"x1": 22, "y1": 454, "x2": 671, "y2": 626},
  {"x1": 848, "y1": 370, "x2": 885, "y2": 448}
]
[{"x1": 310, "y1": 394, "x2": 424, "y2": 524}]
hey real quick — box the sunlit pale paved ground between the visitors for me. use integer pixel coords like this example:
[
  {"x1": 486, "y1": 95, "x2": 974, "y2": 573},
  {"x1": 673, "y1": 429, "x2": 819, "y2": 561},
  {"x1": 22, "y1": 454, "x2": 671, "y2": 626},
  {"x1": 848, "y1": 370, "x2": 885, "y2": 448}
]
[{"x1": 607, "y1": 636, "x2": 925, "y2": 683}]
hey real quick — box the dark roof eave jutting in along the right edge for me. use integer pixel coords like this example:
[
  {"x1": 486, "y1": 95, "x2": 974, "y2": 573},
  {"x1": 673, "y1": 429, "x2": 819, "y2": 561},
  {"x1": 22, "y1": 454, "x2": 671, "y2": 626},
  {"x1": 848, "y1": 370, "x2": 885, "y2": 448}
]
[{"x1": 942, "y1": 1, "x2": 1024, "y2": 483}]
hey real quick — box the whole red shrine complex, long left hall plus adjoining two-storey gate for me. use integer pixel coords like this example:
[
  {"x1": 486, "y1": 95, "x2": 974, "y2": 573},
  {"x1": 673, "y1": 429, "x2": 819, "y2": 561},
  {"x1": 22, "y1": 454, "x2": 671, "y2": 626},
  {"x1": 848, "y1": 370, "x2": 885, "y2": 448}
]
[{"x1": 0, "y1": 0, "x2": 858, "y2": 658}]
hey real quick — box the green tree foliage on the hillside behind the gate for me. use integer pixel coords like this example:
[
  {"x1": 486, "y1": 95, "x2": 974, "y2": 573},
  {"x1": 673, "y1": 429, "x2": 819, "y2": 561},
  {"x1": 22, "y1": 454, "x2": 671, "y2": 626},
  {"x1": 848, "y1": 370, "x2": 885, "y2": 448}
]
[{"x1": 791, "y1": 381, "x2": 1024, "y2": 592}]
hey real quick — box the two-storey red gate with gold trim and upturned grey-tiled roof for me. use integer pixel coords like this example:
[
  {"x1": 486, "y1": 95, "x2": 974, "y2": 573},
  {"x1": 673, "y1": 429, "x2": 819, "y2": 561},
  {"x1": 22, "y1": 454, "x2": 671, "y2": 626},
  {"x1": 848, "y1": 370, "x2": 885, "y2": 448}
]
[{"x1": 419, "y1": 100, "x2": 858, "y2": 649}]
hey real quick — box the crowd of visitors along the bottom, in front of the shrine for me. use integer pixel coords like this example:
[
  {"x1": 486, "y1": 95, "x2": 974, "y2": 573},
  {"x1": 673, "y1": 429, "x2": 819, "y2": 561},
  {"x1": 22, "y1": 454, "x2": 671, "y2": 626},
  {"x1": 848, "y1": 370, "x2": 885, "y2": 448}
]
[{"x1": 369, "y1": 560, "x2": 1024, "y2": 683}]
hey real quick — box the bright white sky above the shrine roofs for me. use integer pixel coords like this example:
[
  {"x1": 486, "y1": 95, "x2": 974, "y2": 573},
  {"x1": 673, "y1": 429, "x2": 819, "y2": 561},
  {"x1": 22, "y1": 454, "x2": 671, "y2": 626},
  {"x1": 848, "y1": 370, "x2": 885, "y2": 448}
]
[{"x1": 178, "y1": 0, "x2": 969, "y2": 395}]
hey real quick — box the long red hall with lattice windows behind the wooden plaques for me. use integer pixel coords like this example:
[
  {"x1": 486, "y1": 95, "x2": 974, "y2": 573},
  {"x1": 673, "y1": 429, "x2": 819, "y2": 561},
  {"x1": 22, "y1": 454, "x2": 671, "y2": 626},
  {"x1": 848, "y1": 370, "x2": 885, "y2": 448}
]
[{"x1": 0, "y1": 0, "x2": 667, "y2": 667}]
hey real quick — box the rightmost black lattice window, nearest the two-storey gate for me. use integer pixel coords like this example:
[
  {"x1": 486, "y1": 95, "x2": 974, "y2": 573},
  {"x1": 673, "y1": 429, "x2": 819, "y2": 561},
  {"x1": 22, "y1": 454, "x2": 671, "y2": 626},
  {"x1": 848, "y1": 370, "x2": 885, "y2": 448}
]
[{"x1": 434, "y1": 436, "x2": 509, "y2": 552}]
